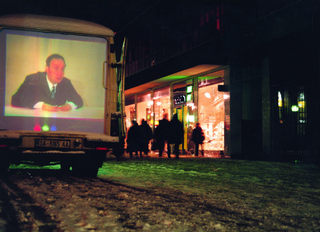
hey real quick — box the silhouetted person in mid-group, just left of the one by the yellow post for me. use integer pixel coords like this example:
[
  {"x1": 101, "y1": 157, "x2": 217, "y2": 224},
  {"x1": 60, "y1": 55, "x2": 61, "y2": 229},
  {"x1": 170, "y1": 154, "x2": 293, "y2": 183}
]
[{"x1": 154, "y1": 113, "x2": 170, "y2": 157}]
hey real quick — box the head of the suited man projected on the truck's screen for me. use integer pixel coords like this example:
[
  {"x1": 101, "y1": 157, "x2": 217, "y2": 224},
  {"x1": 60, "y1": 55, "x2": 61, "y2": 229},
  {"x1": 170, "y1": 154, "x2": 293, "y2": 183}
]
[{"x1": 46, "y1": 54, "x2": 66, "y2": 85}]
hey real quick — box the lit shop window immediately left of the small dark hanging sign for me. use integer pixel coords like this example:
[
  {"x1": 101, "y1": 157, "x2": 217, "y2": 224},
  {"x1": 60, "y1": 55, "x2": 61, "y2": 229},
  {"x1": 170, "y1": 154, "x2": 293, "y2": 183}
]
[{"x1": 153, "y1": 86, "x2": 171, "y2": 127}]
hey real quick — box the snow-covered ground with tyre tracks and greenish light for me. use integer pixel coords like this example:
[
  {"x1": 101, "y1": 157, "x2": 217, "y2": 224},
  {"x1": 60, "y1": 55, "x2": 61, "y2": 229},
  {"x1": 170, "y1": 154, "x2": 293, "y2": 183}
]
[{"x1": 0, "y1": 156, "x2": 320, "y2": 231}]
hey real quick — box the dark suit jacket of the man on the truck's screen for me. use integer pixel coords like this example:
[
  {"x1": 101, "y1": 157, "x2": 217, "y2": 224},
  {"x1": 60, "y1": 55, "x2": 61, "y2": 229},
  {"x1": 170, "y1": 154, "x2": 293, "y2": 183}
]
[{"x1": 11, "y1": 72, "x2": 83, "y2": 108}]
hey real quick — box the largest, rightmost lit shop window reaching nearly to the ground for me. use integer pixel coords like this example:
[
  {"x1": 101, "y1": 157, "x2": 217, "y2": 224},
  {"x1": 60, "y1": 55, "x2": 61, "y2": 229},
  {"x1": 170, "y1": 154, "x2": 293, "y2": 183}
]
[{"x1": 198, "y1": 70, "x2": 225, "y2": 151}]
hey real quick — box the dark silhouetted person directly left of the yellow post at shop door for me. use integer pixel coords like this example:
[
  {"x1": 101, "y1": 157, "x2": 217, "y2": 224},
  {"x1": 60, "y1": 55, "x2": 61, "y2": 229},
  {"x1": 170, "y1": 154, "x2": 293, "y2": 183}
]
[{"x1": 168, "y1": 114, "x2": 183, "y2": 159}]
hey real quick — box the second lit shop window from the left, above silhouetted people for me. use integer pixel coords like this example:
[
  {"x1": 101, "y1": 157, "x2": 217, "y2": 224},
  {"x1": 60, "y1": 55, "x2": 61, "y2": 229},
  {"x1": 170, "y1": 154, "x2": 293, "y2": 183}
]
[{"x1": 137, "y1": 92, "x2": 153, "y2": 126}]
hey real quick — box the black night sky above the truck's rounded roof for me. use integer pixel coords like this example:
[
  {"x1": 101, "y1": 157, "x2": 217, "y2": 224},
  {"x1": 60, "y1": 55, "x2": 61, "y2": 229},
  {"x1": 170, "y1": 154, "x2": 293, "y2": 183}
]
[{"x1": 0, "y1": 0, "x2": 172, "y2": 32}]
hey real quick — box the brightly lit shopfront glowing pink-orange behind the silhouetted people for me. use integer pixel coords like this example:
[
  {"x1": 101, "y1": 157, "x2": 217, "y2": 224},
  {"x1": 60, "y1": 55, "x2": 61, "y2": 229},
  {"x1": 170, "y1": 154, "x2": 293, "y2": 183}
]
[{"x1": 125, "y1": 65, "x2": 229, "y2": 152}]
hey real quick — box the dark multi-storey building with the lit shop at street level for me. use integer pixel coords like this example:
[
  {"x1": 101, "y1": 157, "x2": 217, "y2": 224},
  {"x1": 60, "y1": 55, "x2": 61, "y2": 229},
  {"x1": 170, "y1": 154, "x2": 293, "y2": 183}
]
[{"x1": 120, "y1": 0, "x2": 320, "y2": 161}]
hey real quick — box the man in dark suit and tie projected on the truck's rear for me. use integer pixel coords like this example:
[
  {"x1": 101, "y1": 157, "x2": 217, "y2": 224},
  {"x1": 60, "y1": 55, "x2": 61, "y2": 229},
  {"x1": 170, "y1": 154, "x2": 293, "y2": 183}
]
[{"x1": 11, "y1": 54, "x2": 83, "y2": 111}]
